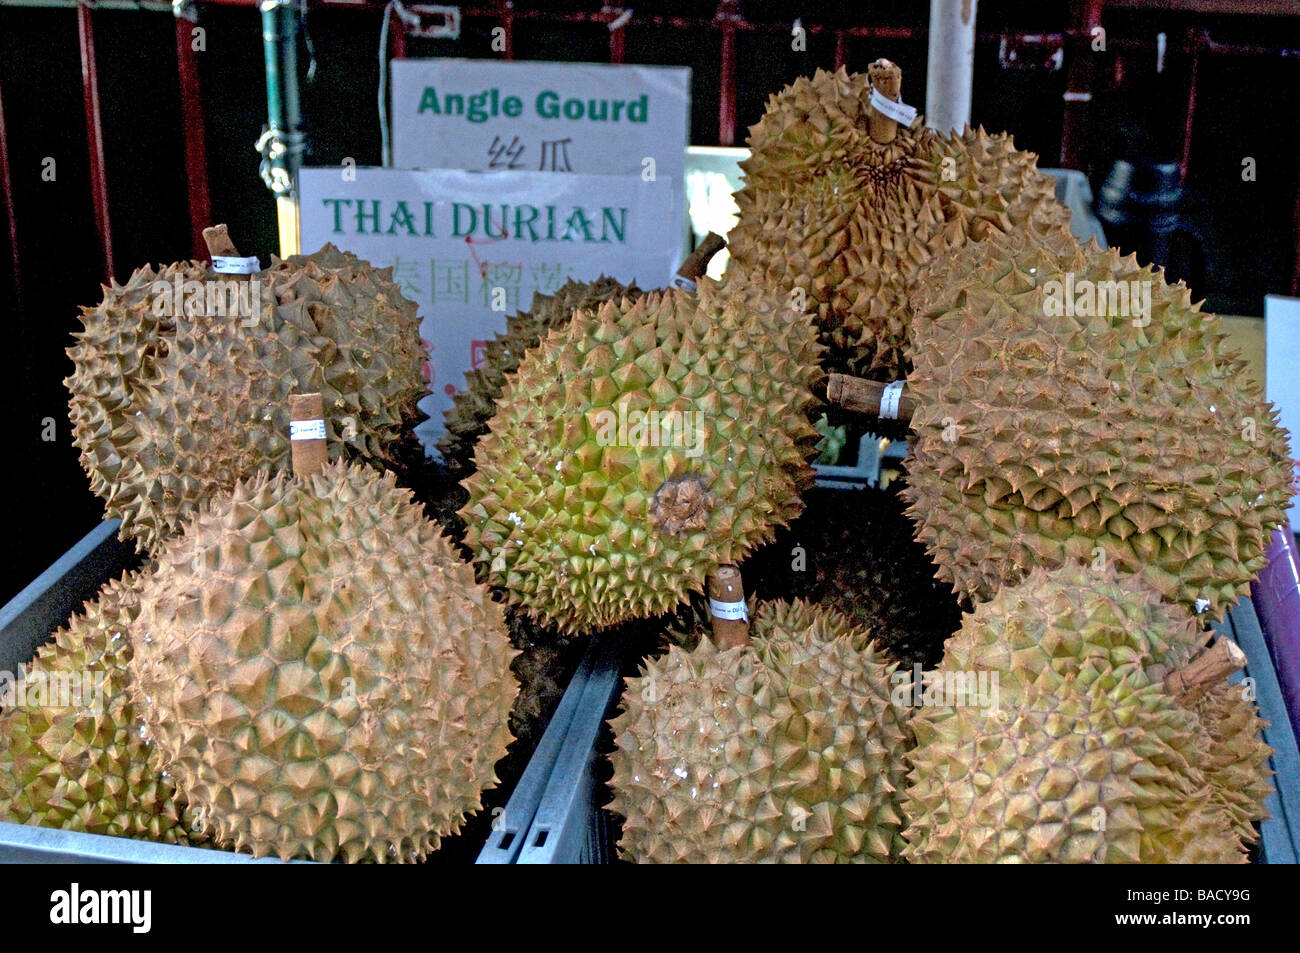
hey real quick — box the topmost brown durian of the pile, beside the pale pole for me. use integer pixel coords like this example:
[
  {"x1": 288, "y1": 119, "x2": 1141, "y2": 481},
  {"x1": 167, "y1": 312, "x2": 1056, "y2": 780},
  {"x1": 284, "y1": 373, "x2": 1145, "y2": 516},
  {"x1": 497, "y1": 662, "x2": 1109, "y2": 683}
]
[{"x1": 728, "y1": 60, "x2": 1070, "y2": 380}]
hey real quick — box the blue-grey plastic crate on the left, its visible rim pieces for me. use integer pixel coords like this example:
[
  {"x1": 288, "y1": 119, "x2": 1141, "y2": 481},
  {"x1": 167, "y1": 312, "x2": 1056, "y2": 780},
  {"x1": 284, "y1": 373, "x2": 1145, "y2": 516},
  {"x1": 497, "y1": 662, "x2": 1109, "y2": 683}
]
[{"x1": 0, "y1": 520, "x2": 553, "y2": 863}]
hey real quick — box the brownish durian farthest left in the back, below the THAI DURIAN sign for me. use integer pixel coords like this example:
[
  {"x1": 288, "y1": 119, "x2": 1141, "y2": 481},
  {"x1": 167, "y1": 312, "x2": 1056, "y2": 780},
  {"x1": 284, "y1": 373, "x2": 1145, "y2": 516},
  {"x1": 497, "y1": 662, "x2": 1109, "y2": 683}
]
[{"x1": 64, "y1": 244, "x2": 425, "y2": 551}]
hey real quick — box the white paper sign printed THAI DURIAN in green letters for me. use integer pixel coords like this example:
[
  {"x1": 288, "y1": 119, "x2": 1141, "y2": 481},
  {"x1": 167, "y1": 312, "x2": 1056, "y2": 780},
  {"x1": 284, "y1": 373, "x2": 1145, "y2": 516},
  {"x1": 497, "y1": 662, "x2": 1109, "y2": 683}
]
[{"x1": 299, "y1": 168, "x2": 684, "y2": 449}]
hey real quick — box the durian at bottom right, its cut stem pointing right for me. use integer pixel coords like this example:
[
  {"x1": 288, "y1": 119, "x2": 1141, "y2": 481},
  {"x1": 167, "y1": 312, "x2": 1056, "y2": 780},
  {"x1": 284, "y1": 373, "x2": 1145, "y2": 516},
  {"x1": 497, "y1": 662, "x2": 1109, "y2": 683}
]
[{"x1": 904, "y1": 563, "x2": 1263, "y2": 863}]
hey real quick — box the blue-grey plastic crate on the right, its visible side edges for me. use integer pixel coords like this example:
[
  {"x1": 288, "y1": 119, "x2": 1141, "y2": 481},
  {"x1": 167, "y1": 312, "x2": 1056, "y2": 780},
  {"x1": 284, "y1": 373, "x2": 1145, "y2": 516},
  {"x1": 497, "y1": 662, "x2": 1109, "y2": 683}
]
[{"x1": 517, "y1": 594, "x2": 1300, "y2": 863}]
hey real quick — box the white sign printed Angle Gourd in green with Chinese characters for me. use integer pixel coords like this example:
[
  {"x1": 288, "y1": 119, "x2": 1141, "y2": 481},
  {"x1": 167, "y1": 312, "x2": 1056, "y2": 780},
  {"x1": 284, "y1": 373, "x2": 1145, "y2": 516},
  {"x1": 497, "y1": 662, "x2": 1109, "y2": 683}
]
[{"x1": 391, "y1": 59, "x2": 690, "y2": 182}]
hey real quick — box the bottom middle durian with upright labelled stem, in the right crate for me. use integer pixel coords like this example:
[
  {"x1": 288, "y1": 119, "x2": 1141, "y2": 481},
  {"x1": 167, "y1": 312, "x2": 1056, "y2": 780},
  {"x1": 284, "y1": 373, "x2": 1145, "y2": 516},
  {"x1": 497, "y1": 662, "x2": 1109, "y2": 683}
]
[{"x1": 611, "y1": 601, "x2": 911, "y2": 863}]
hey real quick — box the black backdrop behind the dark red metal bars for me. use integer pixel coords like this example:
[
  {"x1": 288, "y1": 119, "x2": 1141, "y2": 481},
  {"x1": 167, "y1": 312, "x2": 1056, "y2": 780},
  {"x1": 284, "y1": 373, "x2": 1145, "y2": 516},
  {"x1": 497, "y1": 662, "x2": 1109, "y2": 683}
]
[{"x1": 0, "y1": 0, "x2": 1300, "y2": 602}]
